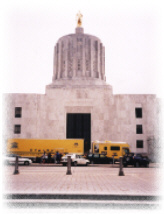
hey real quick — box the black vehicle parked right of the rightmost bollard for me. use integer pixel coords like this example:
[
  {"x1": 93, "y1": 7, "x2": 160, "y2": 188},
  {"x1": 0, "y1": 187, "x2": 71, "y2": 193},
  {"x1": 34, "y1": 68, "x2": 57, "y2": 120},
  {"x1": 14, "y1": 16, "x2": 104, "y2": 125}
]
[{"x1": 123, "y1": 153, "x2": 149, "y2": 167}]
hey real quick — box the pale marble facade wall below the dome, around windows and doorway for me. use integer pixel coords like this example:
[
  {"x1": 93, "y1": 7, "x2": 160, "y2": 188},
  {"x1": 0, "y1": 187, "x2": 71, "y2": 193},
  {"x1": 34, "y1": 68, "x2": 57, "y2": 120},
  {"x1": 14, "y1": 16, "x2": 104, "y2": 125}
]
[{"x1": 4, "y1": 85, "x2": 159, "y2": 160}]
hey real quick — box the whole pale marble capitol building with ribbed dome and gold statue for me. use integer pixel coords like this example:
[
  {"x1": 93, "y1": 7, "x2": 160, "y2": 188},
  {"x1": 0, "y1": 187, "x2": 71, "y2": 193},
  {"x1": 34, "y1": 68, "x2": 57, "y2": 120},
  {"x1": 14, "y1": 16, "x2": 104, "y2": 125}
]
[{"x1": 4, "y1": 15, "x2": 159, "y2": 158}]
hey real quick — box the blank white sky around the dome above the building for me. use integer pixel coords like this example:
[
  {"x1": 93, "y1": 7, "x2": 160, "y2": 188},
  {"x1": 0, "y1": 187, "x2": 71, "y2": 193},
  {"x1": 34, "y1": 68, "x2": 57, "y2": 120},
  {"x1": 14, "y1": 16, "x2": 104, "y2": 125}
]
[{"x1": 0, "y1": 0, "x2": 164, "y2": 97}]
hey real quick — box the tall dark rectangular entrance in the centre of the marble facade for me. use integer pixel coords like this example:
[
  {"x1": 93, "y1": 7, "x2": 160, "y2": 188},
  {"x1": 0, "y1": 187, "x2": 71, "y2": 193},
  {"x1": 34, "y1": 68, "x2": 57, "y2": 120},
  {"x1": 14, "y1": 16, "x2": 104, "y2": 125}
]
[{"x1": 67, "y1": 113, "x2": 91, "y2": 152}]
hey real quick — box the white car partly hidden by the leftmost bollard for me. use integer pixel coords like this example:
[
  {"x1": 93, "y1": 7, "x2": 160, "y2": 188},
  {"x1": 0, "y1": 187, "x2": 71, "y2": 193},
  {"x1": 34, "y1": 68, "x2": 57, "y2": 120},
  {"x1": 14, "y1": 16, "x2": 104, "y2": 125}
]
[{"x1": 4, "y1": 154, "x2": 32, "y2": 165}]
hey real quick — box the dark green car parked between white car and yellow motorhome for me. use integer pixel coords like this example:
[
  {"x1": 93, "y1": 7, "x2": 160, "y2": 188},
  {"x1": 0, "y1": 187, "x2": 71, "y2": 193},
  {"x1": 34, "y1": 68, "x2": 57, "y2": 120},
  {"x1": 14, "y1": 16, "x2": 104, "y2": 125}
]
[{"x1": 87, "y1": 154, "x2": 112, "y2": 164}]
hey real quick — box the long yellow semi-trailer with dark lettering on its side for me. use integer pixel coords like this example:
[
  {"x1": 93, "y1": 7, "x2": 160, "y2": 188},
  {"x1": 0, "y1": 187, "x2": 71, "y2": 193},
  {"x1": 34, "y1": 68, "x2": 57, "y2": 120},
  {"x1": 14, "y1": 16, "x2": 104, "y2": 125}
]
[{"x1": 7, "y1": 139, "x2": 84, "y2": 161}]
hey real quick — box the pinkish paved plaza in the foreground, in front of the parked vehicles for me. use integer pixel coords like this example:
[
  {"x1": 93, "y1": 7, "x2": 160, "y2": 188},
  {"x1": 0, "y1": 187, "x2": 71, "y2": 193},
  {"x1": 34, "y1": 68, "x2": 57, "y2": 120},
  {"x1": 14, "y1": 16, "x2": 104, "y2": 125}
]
[{"x1": 3, "y1": 165, "x2": 162, "y2": 208}]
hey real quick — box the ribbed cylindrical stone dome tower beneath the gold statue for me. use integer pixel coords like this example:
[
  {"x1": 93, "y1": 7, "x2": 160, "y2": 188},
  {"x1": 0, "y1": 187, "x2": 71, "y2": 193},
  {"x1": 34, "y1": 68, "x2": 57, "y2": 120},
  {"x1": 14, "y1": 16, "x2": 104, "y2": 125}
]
[{"x1": 48, "y1": 26, "x2": 106, "y2": 86}]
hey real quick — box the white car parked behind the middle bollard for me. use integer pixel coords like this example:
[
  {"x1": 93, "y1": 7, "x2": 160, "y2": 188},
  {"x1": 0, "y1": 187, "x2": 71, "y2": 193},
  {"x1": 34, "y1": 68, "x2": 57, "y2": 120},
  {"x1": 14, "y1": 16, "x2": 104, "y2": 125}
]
[{"x1": 60, "y1": 154, "x2": 90, "y2": 166}]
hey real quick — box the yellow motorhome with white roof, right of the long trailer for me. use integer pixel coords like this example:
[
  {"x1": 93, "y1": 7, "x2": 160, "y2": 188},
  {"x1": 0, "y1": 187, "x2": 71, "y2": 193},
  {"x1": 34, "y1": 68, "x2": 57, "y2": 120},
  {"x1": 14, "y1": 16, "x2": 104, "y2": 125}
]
[{"x1": 92, "y1": 141, "x2": 130, "y2": 161}]
